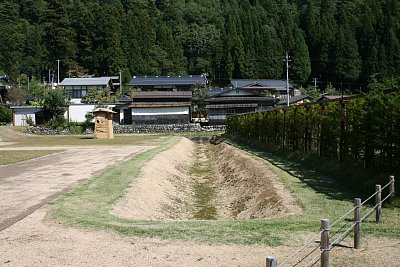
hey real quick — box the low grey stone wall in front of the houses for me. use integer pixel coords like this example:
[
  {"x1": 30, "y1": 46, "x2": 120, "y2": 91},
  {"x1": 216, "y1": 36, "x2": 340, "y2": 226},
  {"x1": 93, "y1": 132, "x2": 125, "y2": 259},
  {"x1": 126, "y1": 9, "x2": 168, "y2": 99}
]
[{"x1": 28, "y1": 124, "x2": 226, "y2": 135}]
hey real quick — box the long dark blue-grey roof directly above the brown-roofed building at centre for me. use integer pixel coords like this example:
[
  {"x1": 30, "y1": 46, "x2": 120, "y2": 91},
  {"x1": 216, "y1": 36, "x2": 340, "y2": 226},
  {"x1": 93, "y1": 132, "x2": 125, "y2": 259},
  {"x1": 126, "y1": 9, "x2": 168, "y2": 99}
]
[{"x1": 129, "y1": 75, "x2": 206, "y2": 87}]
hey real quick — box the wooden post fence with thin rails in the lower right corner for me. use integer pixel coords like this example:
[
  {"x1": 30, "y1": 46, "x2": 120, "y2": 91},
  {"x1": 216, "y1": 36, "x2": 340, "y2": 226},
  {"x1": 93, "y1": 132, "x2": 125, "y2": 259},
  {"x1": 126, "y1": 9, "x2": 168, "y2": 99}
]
[{"x1": 266, "y1": 176, "x2": 395, "y2": 267}]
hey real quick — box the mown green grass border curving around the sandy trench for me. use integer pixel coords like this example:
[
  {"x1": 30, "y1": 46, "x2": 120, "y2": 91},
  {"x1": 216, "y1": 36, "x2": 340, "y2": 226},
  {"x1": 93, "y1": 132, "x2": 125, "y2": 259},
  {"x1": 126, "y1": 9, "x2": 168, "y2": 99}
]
[{"x1": 50, "y1": 136, "x2": 400, "y2": 246}]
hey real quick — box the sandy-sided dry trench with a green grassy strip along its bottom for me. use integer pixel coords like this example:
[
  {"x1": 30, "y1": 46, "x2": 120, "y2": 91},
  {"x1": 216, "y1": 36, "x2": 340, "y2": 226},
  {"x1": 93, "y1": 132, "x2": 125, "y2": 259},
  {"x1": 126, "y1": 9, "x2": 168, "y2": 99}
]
[{"x1": 113, "y1": 138, "x2": 301, "y2": 220}]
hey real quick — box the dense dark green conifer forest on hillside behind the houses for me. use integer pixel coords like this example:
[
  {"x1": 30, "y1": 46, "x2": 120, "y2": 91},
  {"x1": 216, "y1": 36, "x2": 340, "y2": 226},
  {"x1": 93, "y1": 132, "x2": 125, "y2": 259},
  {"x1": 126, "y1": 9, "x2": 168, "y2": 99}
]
[{"x1": 0, "y1": 0, "x2": 400, "y2": 87}]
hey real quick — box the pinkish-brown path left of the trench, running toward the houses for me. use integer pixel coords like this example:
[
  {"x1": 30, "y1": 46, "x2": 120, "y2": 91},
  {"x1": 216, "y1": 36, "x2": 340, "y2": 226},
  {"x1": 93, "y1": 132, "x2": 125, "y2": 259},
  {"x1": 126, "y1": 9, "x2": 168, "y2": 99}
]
[{"x1": 0, "y1": 146, "x2": 150, "y2": 231}]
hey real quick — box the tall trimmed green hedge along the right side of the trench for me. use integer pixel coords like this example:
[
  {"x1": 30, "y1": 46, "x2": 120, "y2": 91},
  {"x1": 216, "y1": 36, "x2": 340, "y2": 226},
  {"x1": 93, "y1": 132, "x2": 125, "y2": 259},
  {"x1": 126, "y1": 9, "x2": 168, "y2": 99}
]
[{"x1": 227, "y1": 91, "x2": 400, "y2": 172}]
